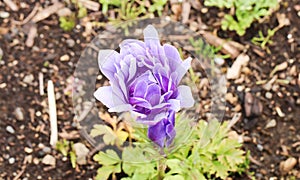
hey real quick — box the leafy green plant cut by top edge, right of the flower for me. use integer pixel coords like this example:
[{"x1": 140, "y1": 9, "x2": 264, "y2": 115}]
[{"x1": 204, "y1": 0, "x2": 278, "y2": 36}]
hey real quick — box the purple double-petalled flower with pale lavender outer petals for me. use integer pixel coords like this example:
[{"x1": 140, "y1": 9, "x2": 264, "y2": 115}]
[{"x1": 94, "y1": 25, "x2": 194, "y2": 147}]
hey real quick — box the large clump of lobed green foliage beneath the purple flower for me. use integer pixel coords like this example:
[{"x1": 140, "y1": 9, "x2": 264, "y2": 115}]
[{"x1": 94, "y1": 116, "x2": 249, "y2": 180}]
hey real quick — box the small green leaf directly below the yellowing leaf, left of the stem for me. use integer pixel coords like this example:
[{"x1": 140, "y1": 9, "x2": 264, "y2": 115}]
[{"x1": 93, "y1": 149, "x2": 121, "y2": 165}]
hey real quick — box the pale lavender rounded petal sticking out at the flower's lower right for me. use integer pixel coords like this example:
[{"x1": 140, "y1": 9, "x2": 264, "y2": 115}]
[{"x1": 177, "y1": 85, "x2": 195, "y2": 108}]
